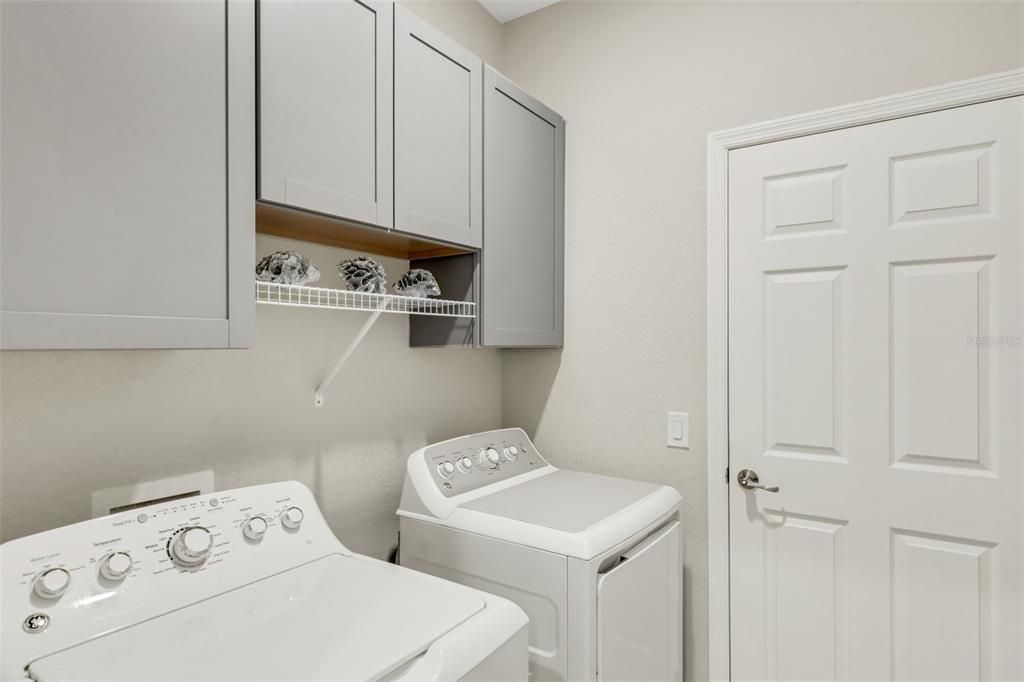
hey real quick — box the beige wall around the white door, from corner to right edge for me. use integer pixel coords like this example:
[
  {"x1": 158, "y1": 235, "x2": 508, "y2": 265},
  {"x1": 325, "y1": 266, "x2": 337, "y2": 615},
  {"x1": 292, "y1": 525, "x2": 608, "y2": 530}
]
[{"x1": 502, "y1": 0, "x2": 1024, "y2": 680}]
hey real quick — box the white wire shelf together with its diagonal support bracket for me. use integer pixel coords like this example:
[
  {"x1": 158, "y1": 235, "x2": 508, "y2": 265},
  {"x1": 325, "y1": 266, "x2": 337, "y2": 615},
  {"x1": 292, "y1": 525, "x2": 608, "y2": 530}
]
[{"x1": 256, "y1": 282, "x2": 476, "y2": 408}]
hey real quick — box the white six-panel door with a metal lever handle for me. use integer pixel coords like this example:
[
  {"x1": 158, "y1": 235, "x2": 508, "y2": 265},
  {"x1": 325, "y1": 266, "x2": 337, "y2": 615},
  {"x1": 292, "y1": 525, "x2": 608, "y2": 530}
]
[{"x1": 729, "y1": 97, "x2": 1024, "y2": 680}]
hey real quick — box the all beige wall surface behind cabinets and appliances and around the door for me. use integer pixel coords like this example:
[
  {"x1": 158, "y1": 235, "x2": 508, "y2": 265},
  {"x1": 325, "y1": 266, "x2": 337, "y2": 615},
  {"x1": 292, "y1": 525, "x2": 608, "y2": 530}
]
[{"x1": 0, "y1": 1, "x2": 1024, "y2": 680}]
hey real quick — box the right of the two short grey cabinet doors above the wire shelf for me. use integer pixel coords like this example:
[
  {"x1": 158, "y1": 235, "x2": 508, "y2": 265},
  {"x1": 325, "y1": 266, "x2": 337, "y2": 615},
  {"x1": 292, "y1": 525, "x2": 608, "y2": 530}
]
[{"x1": 394, "y1": 7, "x2": 483, "y2": 247}]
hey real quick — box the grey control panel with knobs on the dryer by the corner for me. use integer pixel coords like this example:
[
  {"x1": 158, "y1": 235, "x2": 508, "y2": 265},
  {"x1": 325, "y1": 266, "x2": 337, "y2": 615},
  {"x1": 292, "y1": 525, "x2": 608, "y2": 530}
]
[{"x1": 424, "y1": 429, "x2": 547, "y2": 498}]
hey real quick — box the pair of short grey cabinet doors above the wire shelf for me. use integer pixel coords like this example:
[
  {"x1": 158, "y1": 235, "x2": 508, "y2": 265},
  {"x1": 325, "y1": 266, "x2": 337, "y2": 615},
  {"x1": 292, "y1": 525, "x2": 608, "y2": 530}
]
[{"x1": 259, "y1": 0, "x2": 482, "y2": 249}]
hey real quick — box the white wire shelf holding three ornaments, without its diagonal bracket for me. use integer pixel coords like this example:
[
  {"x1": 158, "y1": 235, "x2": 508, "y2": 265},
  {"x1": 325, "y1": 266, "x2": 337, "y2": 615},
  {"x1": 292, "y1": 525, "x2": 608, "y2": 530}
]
[{"x1": 256, "y1": 281, "x2": 476, "y2": 317}]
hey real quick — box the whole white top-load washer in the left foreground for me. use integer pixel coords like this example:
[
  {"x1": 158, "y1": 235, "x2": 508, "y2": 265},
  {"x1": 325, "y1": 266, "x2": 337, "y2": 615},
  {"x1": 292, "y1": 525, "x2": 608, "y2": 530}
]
[{"x1": 0, "y1": 482, "x2": 527, "y2": 682}]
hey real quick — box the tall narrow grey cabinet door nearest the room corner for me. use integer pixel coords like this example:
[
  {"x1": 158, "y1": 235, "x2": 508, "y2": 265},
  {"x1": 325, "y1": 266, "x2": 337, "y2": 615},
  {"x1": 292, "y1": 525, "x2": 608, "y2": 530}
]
[{"x1": 480, "y1": 67, "x2": 565, "y2": 347}]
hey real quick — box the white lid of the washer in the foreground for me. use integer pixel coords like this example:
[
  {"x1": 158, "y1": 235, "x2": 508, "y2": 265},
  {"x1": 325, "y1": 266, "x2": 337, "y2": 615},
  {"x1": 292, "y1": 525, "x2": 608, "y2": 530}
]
[{"x1": 29, "y1": 555, "x2": 484, "y2": 682}]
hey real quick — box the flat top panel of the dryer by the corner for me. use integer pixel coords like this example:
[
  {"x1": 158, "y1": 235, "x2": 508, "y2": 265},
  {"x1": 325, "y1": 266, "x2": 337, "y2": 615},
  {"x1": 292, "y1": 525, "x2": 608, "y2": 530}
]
[{"x1": 460, "y1": 469, "x2": 665, "y2": 532}]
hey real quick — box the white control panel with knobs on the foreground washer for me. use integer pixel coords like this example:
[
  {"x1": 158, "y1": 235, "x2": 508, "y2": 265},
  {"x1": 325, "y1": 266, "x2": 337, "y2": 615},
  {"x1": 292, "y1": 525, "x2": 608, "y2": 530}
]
[{"x1": 0, "y1": 481, "x2": 350, "y2": 660}]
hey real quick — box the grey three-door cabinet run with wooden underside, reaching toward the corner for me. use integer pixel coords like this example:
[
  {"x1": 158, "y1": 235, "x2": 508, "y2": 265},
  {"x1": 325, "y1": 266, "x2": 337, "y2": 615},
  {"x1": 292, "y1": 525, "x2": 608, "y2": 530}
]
[{"x1": 257, "y1": 6, "x2": 565, "y2": 347}]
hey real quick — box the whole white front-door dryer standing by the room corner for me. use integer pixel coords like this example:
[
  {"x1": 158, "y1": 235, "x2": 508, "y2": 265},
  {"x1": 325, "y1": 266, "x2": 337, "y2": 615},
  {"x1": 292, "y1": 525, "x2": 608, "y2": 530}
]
[{"x1": 398, "y1": 429, "x2": 682, "y2": 682}]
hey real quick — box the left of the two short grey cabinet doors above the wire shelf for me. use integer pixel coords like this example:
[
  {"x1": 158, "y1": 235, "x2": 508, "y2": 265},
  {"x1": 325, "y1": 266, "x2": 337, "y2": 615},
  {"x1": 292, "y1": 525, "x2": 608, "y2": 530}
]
[{"x1": 259, "y1": 0, "x2": 393, "y2": 227}]
